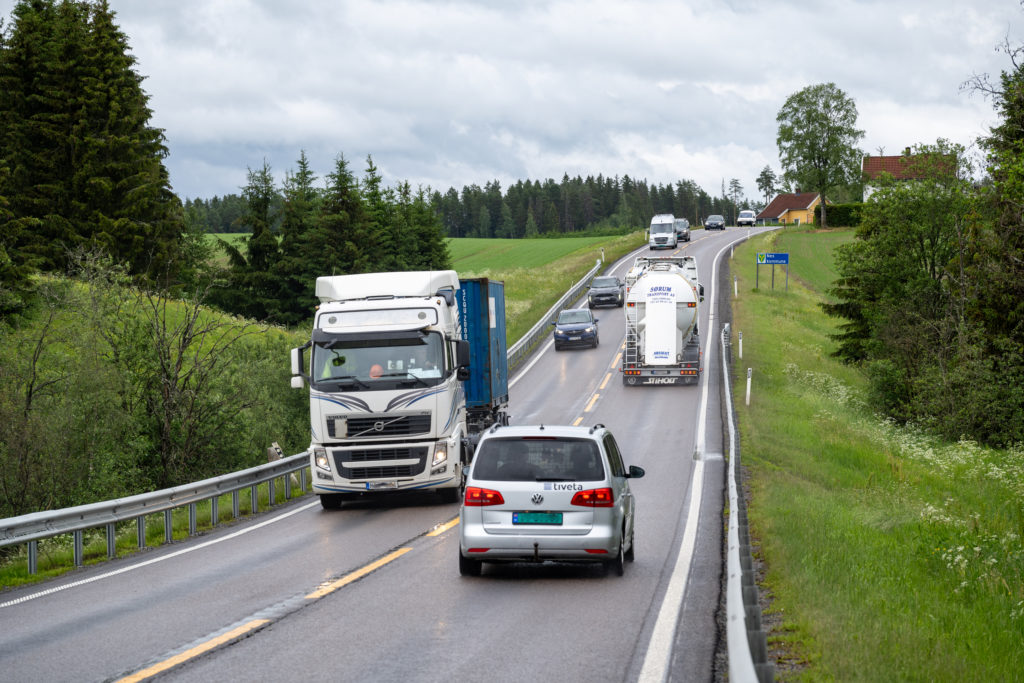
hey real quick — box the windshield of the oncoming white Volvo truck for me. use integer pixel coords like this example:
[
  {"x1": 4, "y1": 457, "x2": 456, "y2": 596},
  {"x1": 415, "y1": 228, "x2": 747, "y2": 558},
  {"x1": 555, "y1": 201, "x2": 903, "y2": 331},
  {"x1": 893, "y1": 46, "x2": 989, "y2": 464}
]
[{"x1": 311, "y1": 332, "x2": 444, "y2": 391}]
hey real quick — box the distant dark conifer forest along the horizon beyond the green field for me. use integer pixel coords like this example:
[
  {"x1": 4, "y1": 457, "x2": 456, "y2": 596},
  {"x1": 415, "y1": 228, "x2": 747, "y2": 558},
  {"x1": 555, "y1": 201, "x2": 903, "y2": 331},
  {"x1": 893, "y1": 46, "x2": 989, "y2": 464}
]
[{"x1": 184, "y1": 174, "x2": 745, "y2": 238}]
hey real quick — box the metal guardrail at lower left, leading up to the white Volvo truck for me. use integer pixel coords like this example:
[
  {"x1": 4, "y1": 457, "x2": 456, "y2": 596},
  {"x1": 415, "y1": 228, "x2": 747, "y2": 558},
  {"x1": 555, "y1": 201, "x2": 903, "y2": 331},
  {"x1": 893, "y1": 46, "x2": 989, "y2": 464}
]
[{"x1": 0, "y1": 452, "x2": 309, "y2": 574}]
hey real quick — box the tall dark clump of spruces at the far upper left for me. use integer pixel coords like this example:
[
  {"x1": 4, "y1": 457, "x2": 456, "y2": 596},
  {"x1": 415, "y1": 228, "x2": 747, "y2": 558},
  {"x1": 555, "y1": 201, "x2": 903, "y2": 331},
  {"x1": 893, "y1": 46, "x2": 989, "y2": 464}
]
[{"x1": 0, "y1": 0, "x2": 182, "y2": 276}]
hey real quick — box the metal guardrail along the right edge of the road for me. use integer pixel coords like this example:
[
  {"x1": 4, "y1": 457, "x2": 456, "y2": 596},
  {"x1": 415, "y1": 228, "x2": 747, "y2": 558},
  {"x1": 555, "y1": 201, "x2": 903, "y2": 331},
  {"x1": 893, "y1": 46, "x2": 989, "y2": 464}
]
[{"x1": 722, "y1": 323, "x2": 775, "y2": 683}]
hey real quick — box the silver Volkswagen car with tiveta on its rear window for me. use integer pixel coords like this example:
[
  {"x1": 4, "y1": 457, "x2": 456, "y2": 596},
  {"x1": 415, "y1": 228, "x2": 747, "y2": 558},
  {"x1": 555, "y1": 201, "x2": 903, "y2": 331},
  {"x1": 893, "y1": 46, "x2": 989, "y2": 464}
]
[{"x1": 459, "y1": 424, "x2": 644, "y2": 577}]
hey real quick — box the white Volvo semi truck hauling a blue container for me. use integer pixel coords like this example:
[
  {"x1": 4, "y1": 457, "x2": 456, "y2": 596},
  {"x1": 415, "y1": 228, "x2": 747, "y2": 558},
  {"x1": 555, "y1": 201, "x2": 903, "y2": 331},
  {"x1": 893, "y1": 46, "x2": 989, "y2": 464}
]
[{"x1": 292, "y1": 270, "x2": 508, "y2": 509}]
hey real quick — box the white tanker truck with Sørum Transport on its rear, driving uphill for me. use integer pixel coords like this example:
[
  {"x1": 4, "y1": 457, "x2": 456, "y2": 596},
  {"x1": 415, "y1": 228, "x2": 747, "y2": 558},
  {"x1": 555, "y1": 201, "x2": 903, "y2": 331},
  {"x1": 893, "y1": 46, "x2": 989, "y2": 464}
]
[{"x1": 622, "y1": 256, "x2": 703, "y2": 385}]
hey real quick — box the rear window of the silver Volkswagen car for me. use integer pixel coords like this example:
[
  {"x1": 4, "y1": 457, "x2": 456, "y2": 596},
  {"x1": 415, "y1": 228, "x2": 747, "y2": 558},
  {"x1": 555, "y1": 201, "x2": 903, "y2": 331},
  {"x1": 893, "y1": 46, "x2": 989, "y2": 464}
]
[{"x1": 472, "y1": 437, "x2": 604, "y2": 481}]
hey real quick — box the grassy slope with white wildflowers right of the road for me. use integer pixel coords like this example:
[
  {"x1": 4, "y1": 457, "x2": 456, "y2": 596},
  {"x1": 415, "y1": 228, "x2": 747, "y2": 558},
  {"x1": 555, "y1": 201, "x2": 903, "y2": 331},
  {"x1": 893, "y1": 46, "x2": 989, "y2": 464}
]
[{"x1": 732, "y1": 228, "x2": 1024, "y2": 681}]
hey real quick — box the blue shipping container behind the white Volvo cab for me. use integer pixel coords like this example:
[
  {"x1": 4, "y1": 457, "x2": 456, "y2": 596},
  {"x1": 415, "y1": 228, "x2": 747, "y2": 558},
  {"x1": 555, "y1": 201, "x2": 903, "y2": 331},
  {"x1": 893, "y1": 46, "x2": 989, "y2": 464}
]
[{"x1": 458, "y1": 278, "x2": 509, "y2": 409}]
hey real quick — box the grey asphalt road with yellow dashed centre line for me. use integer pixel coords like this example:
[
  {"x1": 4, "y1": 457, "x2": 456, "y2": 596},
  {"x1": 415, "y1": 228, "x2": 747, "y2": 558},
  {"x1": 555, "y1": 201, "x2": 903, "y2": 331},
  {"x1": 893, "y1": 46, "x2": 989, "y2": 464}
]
[{"x1": 0, "y1": 228, "x2": 760, "y2": 681}]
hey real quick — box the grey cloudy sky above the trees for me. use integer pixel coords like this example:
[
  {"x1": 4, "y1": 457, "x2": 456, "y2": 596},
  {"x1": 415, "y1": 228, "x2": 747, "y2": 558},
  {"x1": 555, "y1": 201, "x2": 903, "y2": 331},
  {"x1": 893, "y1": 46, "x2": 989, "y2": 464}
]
[{"x1": 0, "y1": 0, "x2": 1024, "y2": 198}]
